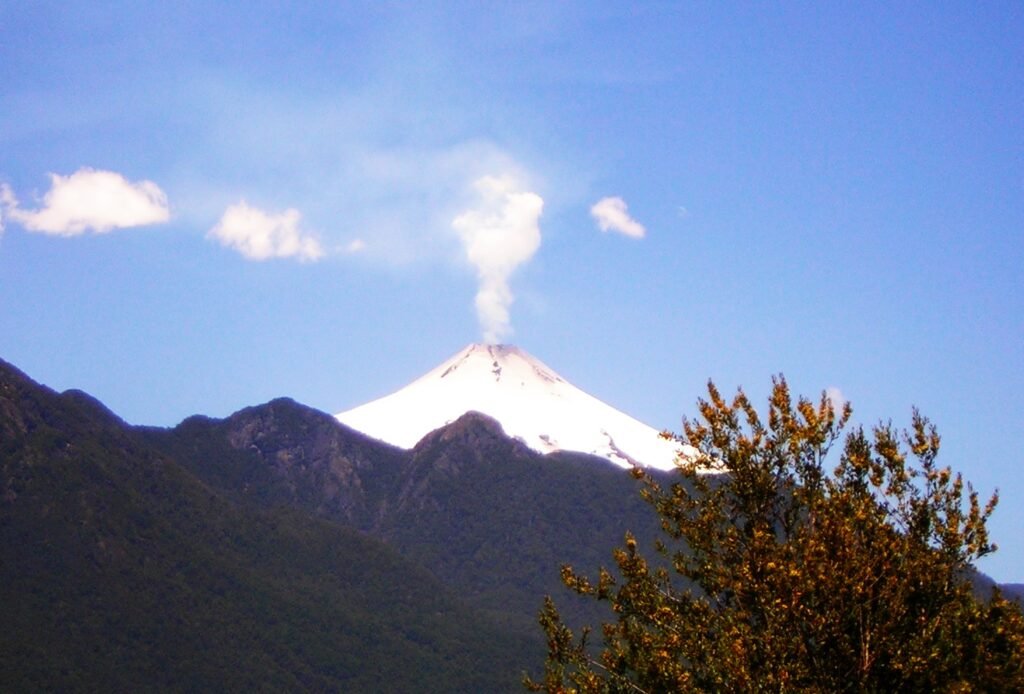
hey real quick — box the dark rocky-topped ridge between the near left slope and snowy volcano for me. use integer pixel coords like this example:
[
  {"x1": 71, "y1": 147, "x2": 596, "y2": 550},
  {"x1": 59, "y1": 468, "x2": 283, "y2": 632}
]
[{"x1": 145, "y1": 399, "x2": 675, "y2": 648}]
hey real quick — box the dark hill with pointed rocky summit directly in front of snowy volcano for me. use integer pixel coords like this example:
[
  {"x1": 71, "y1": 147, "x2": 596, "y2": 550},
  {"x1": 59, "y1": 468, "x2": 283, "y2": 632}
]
[{"x1": 381, "y1": 413, "x2": 656, "y2": 630}]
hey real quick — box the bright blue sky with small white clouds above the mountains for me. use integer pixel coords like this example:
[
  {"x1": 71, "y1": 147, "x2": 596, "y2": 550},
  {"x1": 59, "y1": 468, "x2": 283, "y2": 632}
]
[{"x1": 0, "y1": 2, "x2": 1024, "y2": 580}]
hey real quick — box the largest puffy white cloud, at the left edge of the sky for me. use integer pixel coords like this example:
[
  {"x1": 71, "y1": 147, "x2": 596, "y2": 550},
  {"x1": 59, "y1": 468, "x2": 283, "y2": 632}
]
[{"x1": 0, "y1": 168, "x2": 171, "y2": 236}]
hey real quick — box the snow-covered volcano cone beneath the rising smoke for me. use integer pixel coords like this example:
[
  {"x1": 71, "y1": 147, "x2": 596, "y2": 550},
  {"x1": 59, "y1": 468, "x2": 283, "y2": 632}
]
[{"x1": 336, "y1": 344, "x2": 692, "y2": 470}]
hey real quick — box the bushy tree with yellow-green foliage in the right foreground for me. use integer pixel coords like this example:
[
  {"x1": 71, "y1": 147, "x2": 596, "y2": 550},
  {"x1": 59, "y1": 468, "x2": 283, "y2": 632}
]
[{"x1": 526, "y1": 378, "x2": 1024, "y2": 692}]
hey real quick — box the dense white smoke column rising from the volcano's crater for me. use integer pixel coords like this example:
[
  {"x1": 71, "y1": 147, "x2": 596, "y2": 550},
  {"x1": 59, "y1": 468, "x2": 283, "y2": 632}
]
[{"x1": 452, "y1": 176, "x2": 544, "y2": 344}]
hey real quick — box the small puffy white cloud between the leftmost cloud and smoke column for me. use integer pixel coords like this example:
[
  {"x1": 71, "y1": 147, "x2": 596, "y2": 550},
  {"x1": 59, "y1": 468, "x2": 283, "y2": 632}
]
[{"x1": 207, "y1": 201, "x2": 324, "y2": 260}]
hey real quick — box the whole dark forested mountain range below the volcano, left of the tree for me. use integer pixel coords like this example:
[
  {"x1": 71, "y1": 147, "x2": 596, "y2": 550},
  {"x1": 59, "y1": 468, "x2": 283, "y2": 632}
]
[{"x1": 8, "y1": 361, "x2": 1015, "y2": 691}]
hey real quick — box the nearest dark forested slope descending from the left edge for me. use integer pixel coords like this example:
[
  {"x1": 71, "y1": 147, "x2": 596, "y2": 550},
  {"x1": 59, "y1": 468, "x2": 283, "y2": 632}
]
[{"x1": 0, "y1": 362, "x2": 536, "y2": 691}]
